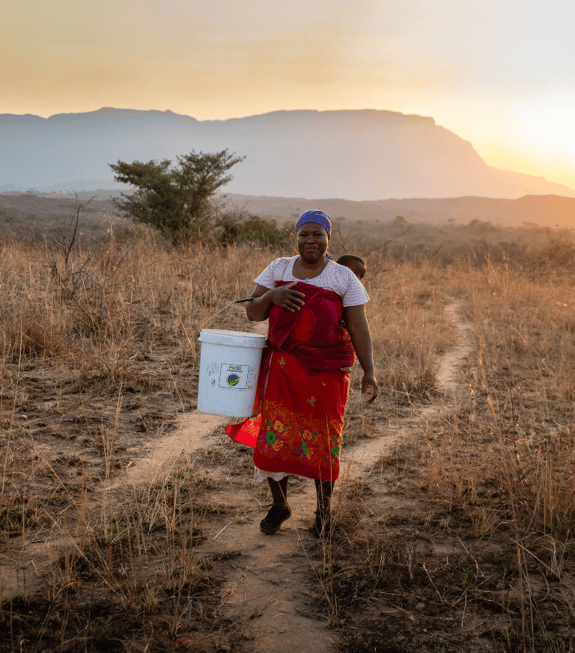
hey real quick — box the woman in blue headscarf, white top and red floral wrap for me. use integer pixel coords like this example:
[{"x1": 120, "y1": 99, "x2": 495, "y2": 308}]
[{"x1": 226, "y1": 211, "x2": 378, "y2": 537}]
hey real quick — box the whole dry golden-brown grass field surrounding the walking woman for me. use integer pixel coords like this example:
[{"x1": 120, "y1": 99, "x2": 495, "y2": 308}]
[{"x1": 0, "y1": 223, "x2": 575, "y2": 653}]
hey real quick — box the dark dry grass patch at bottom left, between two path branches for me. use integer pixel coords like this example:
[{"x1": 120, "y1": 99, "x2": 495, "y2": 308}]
[{"x1": 0, "y1": 458, "x2": 248, "y2": 651}]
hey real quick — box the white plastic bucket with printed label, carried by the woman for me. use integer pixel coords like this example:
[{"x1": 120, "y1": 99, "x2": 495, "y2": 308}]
[{"x1": 198, "y1": 329, "x2": 266, "y2": 417}]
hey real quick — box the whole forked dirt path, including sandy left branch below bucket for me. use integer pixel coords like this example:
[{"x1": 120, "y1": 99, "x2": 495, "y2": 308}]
[{"x1": 2, "y1": 304, "x2": 472, "y2": 653}]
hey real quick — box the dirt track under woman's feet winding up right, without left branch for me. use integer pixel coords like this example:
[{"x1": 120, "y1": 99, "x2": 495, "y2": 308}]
[{"x1": 212, "y1": 305, "x2": 471, "y2": 653}]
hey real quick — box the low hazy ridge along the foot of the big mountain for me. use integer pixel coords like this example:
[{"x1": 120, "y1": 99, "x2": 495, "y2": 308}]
[{"x1": 0, "y1": 193, "x2": 575, "y2": 263}]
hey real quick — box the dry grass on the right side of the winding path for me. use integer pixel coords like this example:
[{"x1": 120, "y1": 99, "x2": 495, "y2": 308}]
[{"x1": 308, "y1": 247, "x2": 575, "y2": 653}]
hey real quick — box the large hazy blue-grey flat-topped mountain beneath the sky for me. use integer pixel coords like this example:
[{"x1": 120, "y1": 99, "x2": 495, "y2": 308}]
[{"x1": 0, "y1": 108, "x2": 575, "y2": 200}]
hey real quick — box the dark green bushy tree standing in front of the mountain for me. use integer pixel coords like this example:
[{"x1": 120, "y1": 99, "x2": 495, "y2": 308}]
[{"x1": 110, "y1": 149, "x2": 245, "y2": 244}]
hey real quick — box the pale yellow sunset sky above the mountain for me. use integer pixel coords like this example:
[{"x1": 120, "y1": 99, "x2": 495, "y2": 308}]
[{"x1": 4, "y1": 0, "x2": 575, "y2": 188}]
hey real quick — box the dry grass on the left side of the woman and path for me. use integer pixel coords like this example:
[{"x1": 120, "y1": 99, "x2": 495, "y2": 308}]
[{"x1": 0, "y1": 233, "x2": 292, "y2": 651}]
